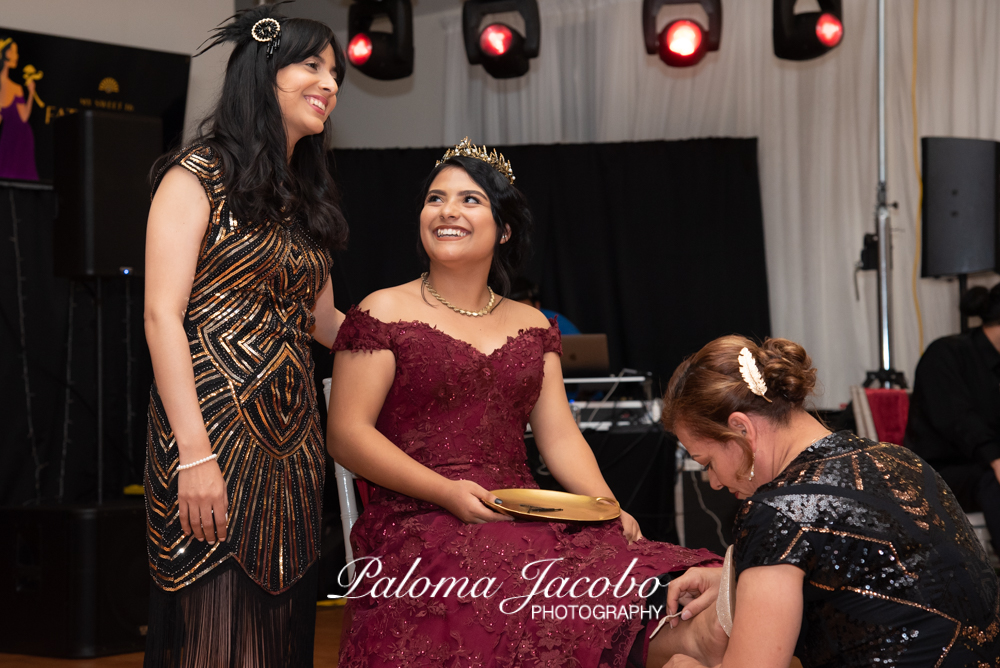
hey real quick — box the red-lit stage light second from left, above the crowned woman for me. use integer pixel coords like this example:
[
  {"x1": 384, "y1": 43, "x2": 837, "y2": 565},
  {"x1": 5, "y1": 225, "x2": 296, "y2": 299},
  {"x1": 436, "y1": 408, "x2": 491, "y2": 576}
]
[{"x1": 462, "y1": 0, "x2": 541, "y2": 79}]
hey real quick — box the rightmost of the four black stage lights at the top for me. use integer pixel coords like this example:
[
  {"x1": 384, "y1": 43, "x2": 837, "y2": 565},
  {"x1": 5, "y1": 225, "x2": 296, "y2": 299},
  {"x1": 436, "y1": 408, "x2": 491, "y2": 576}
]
[{"x1": 773, "y1": 0, "x2": 844, "y2": 60}]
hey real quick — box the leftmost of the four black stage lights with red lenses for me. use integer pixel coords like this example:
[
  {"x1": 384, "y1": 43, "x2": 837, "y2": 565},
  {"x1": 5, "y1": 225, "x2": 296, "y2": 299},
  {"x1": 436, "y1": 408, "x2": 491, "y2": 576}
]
[{"x1": 347, "y1": 0, "x2": 413, "y2": 81}]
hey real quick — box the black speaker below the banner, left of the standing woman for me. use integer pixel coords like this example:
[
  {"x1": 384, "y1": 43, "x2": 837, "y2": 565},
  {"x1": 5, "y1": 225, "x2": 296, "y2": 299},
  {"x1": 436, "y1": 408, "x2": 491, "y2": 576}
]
[{"x1": 53, "y1": 110, "x2": 163, "y2": 278}]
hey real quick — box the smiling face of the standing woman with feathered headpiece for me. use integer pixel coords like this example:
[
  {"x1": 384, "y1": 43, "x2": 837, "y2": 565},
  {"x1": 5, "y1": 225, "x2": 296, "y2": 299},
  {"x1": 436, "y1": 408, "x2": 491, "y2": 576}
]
[{"x1": 275, "y1": 44, "x2": 338, "y2": 147}]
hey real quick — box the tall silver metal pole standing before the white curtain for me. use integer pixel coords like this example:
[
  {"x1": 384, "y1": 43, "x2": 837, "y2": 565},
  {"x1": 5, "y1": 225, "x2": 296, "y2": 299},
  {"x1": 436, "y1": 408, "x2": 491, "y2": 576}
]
[{"x1": 865, "y1": 0, "x2": 906, "y2": 387}]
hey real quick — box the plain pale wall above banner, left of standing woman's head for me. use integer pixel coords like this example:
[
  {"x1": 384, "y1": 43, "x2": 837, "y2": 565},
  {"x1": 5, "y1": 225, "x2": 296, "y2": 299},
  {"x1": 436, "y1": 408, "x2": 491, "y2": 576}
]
[{"x1": 0, "y1": 0, "x2": 233, "y2": 137}]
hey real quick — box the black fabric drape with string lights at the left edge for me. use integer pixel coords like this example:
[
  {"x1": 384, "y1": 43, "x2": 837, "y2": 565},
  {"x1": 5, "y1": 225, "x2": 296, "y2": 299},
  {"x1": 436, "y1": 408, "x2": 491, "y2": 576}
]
[{"x1": 0, "y1": 185, "x2": 153, "y2": 505}]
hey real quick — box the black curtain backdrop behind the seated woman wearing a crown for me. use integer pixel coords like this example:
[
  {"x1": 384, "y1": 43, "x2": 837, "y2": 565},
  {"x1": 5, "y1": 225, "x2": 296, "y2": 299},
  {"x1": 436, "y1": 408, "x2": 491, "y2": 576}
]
[{"x1": 334, "y1": 139, "x2": 771, "y2": 391}]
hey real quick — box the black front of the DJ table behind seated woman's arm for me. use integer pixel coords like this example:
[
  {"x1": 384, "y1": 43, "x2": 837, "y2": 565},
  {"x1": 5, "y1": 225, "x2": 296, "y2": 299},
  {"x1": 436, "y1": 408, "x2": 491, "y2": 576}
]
[{"x1": 524, "y1": 423, "x2": 677, "y2": 543}]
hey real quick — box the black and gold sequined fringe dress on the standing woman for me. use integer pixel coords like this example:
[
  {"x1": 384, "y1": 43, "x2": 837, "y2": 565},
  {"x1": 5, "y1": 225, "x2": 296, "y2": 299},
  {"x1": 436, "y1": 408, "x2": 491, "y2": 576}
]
[{"x1": 145, "y1": 145, "x2": 331, "y2": 667}]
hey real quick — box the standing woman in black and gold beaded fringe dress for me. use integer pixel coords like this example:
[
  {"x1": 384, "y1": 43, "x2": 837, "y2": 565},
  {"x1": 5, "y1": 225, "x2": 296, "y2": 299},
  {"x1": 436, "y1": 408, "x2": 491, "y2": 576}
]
[{"x1": 139, "y1": 6, "x2": 347, "y2": 668}]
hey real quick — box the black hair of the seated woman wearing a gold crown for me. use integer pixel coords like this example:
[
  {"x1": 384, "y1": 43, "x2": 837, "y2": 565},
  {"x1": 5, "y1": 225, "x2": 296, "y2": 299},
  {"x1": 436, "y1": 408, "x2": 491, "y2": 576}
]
[{"x1": 417, "y1": 156, "x2": 531, "y2": 297}]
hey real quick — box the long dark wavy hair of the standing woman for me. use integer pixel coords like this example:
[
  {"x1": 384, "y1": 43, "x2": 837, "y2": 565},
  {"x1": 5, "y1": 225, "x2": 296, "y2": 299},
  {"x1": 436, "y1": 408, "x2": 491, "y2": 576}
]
[{"x1": 153, "y1": 3, "x2": 347, "y2": 250}]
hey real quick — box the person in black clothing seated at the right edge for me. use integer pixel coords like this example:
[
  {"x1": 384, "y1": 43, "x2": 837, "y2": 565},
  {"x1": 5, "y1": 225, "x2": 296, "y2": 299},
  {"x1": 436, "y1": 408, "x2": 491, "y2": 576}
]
[{"x1": 903, "y1": 284, "x2": 1000, "y2": 554}]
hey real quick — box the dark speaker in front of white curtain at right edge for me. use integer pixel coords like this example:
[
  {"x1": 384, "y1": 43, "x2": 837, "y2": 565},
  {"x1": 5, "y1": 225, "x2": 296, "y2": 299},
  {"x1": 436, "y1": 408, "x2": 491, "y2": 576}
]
[{"x1": 920, "y1": 137, "x2": 1000, "y2": 277}]
